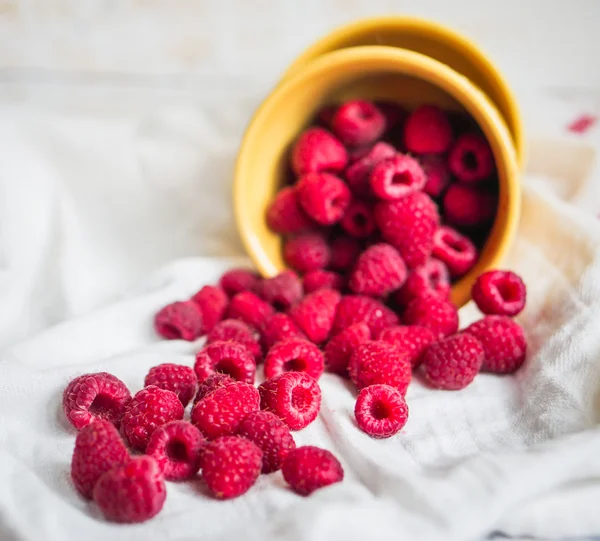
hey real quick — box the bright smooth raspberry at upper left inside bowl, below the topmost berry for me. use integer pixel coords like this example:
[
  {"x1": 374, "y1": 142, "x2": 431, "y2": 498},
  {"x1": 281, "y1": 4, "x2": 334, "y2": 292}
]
[{"x1": 292, "y1": 128, "x2": 348, "y2": 175}]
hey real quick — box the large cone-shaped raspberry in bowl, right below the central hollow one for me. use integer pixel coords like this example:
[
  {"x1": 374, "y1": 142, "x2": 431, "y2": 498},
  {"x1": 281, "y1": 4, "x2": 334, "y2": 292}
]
[{"x1": 375, "y1": 192, "x2": 439, "y2": 269}]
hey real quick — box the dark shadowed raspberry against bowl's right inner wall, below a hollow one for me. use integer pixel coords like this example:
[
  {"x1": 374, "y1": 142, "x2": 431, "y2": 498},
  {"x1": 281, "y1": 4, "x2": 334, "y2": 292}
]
[{"x1": 443, "y1": 184, "x2": 498, "y2": 227}]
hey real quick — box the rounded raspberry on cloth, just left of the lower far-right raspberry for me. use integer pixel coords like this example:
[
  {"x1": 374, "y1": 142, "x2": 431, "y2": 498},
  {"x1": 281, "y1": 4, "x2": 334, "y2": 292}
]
[{"x1": 422, "y1": 333, "x2": 484, "y2": 390}]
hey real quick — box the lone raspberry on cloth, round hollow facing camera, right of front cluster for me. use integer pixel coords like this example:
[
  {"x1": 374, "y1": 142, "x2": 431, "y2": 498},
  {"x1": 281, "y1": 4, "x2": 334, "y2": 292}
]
[{"x1": 354, "y1": 385, "x2": 408, "y2": 438}]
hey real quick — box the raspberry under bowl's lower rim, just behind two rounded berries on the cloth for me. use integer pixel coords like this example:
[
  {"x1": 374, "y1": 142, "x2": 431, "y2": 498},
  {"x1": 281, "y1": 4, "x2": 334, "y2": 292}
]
[{"x1": 402, "y1": 296, "x2": 458, "y2": 338}]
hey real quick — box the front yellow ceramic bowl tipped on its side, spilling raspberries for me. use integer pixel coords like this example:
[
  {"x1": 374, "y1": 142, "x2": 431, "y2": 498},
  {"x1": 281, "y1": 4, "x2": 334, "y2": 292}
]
[{"x1": 234, "y1": 46, "x2": 520, "y2": 306}]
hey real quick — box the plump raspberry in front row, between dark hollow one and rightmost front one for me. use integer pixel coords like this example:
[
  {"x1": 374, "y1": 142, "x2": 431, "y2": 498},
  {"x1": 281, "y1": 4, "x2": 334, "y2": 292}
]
[{"x1": 201, "y1": 436, "x2": 262, "y2": 500}]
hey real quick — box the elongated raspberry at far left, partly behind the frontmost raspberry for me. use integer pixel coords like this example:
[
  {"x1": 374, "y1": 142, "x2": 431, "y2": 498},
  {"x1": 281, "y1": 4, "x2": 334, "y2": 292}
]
[{"x1": 71, "y1": 421, "x2": 129, "y2": 499}]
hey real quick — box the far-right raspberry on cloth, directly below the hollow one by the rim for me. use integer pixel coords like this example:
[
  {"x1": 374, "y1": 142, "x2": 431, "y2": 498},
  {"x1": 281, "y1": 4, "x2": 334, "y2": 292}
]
[{"x1": 465, "y1": 316, "x2": 527, "y2": 374}]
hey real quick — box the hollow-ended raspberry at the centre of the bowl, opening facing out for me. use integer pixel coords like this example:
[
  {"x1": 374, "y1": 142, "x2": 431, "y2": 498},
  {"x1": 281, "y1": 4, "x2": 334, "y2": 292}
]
[{"x1": 370, "y1": 154, "x2": 427, "y2": 201}]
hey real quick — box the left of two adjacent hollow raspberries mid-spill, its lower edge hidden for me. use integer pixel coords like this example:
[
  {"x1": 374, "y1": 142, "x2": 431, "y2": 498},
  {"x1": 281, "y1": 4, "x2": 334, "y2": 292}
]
[{"x1": 194, "y1": 342, "x2": 256, "y2": 383}]
